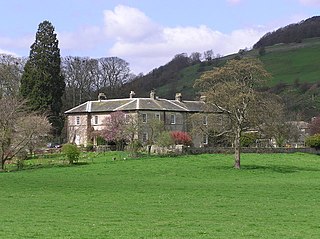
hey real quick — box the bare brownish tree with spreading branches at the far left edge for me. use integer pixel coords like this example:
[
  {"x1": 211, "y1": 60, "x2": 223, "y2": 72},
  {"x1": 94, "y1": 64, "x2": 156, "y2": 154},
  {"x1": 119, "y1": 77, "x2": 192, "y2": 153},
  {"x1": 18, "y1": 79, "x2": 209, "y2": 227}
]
[{"x1": 0, "y1": 97, "x2": 50, "y2": 170}]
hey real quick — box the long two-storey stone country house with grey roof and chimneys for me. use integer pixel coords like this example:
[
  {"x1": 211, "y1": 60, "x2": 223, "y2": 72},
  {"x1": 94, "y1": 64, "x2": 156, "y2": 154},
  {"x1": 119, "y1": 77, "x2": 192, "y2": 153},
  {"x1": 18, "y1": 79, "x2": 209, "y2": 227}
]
[{"x1": 65, "y1": 91, "x2": 215, "y2": 147}]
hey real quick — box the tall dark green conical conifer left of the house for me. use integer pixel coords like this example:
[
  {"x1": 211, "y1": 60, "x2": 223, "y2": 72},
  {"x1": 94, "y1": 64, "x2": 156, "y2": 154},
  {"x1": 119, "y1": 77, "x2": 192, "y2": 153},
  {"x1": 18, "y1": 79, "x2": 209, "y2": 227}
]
[{"x1": 20, "y1": 21, "x2": 65, "y2": 137}]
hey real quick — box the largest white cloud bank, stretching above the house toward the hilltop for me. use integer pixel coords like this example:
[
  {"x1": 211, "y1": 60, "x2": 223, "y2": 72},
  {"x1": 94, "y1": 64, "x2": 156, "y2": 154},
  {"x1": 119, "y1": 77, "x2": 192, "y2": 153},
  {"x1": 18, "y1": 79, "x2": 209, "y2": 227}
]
[{"x1": 105, "y1": 6, "x2": 266, "y2": 73}]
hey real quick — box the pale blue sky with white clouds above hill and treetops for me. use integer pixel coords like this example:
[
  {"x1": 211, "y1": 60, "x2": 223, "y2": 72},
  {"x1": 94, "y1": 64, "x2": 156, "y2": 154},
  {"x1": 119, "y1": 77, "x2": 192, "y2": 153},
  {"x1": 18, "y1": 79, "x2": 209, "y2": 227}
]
[{"x1": 0, "y1": 0, "x2": 320, "y2": 74}]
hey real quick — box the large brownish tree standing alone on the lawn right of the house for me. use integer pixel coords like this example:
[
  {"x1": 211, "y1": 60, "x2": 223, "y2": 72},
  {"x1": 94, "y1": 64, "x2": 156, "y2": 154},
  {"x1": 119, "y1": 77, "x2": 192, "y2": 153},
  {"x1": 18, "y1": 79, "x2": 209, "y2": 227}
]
[{"x1": 195, "y1": 58, "x2": 270, "y2": 169}]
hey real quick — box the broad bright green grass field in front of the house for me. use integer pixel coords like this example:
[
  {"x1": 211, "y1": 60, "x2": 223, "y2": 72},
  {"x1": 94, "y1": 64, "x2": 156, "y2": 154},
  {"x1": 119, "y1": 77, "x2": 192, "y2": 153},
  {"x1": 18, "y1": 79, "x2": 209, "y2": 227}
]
[{"x1": 0, "y1": 154, "x2": 320, "y2": 239}]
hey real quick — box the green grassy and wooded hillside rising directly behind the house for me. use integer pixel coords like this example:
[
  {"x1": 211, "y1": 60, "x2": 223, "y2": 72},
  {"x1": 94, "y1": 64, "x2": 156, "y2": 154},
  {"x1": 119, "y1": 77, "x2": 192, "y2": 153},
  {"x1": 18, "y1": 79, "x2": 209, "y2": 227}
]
[{"x1": 124, "y1": 38, "x2": 320, "y2": 121}]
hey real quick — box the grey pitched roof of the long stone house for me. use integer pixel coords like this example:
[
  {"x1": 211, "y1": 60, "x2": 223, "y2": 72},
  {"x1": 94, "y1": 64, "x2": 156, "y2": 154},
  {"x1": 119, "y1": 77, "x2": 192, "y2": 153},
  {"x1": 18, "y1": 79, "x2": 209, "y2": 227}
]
[{"x1": 65, "y1": 98, "x2": 210, "y2": 114}]
